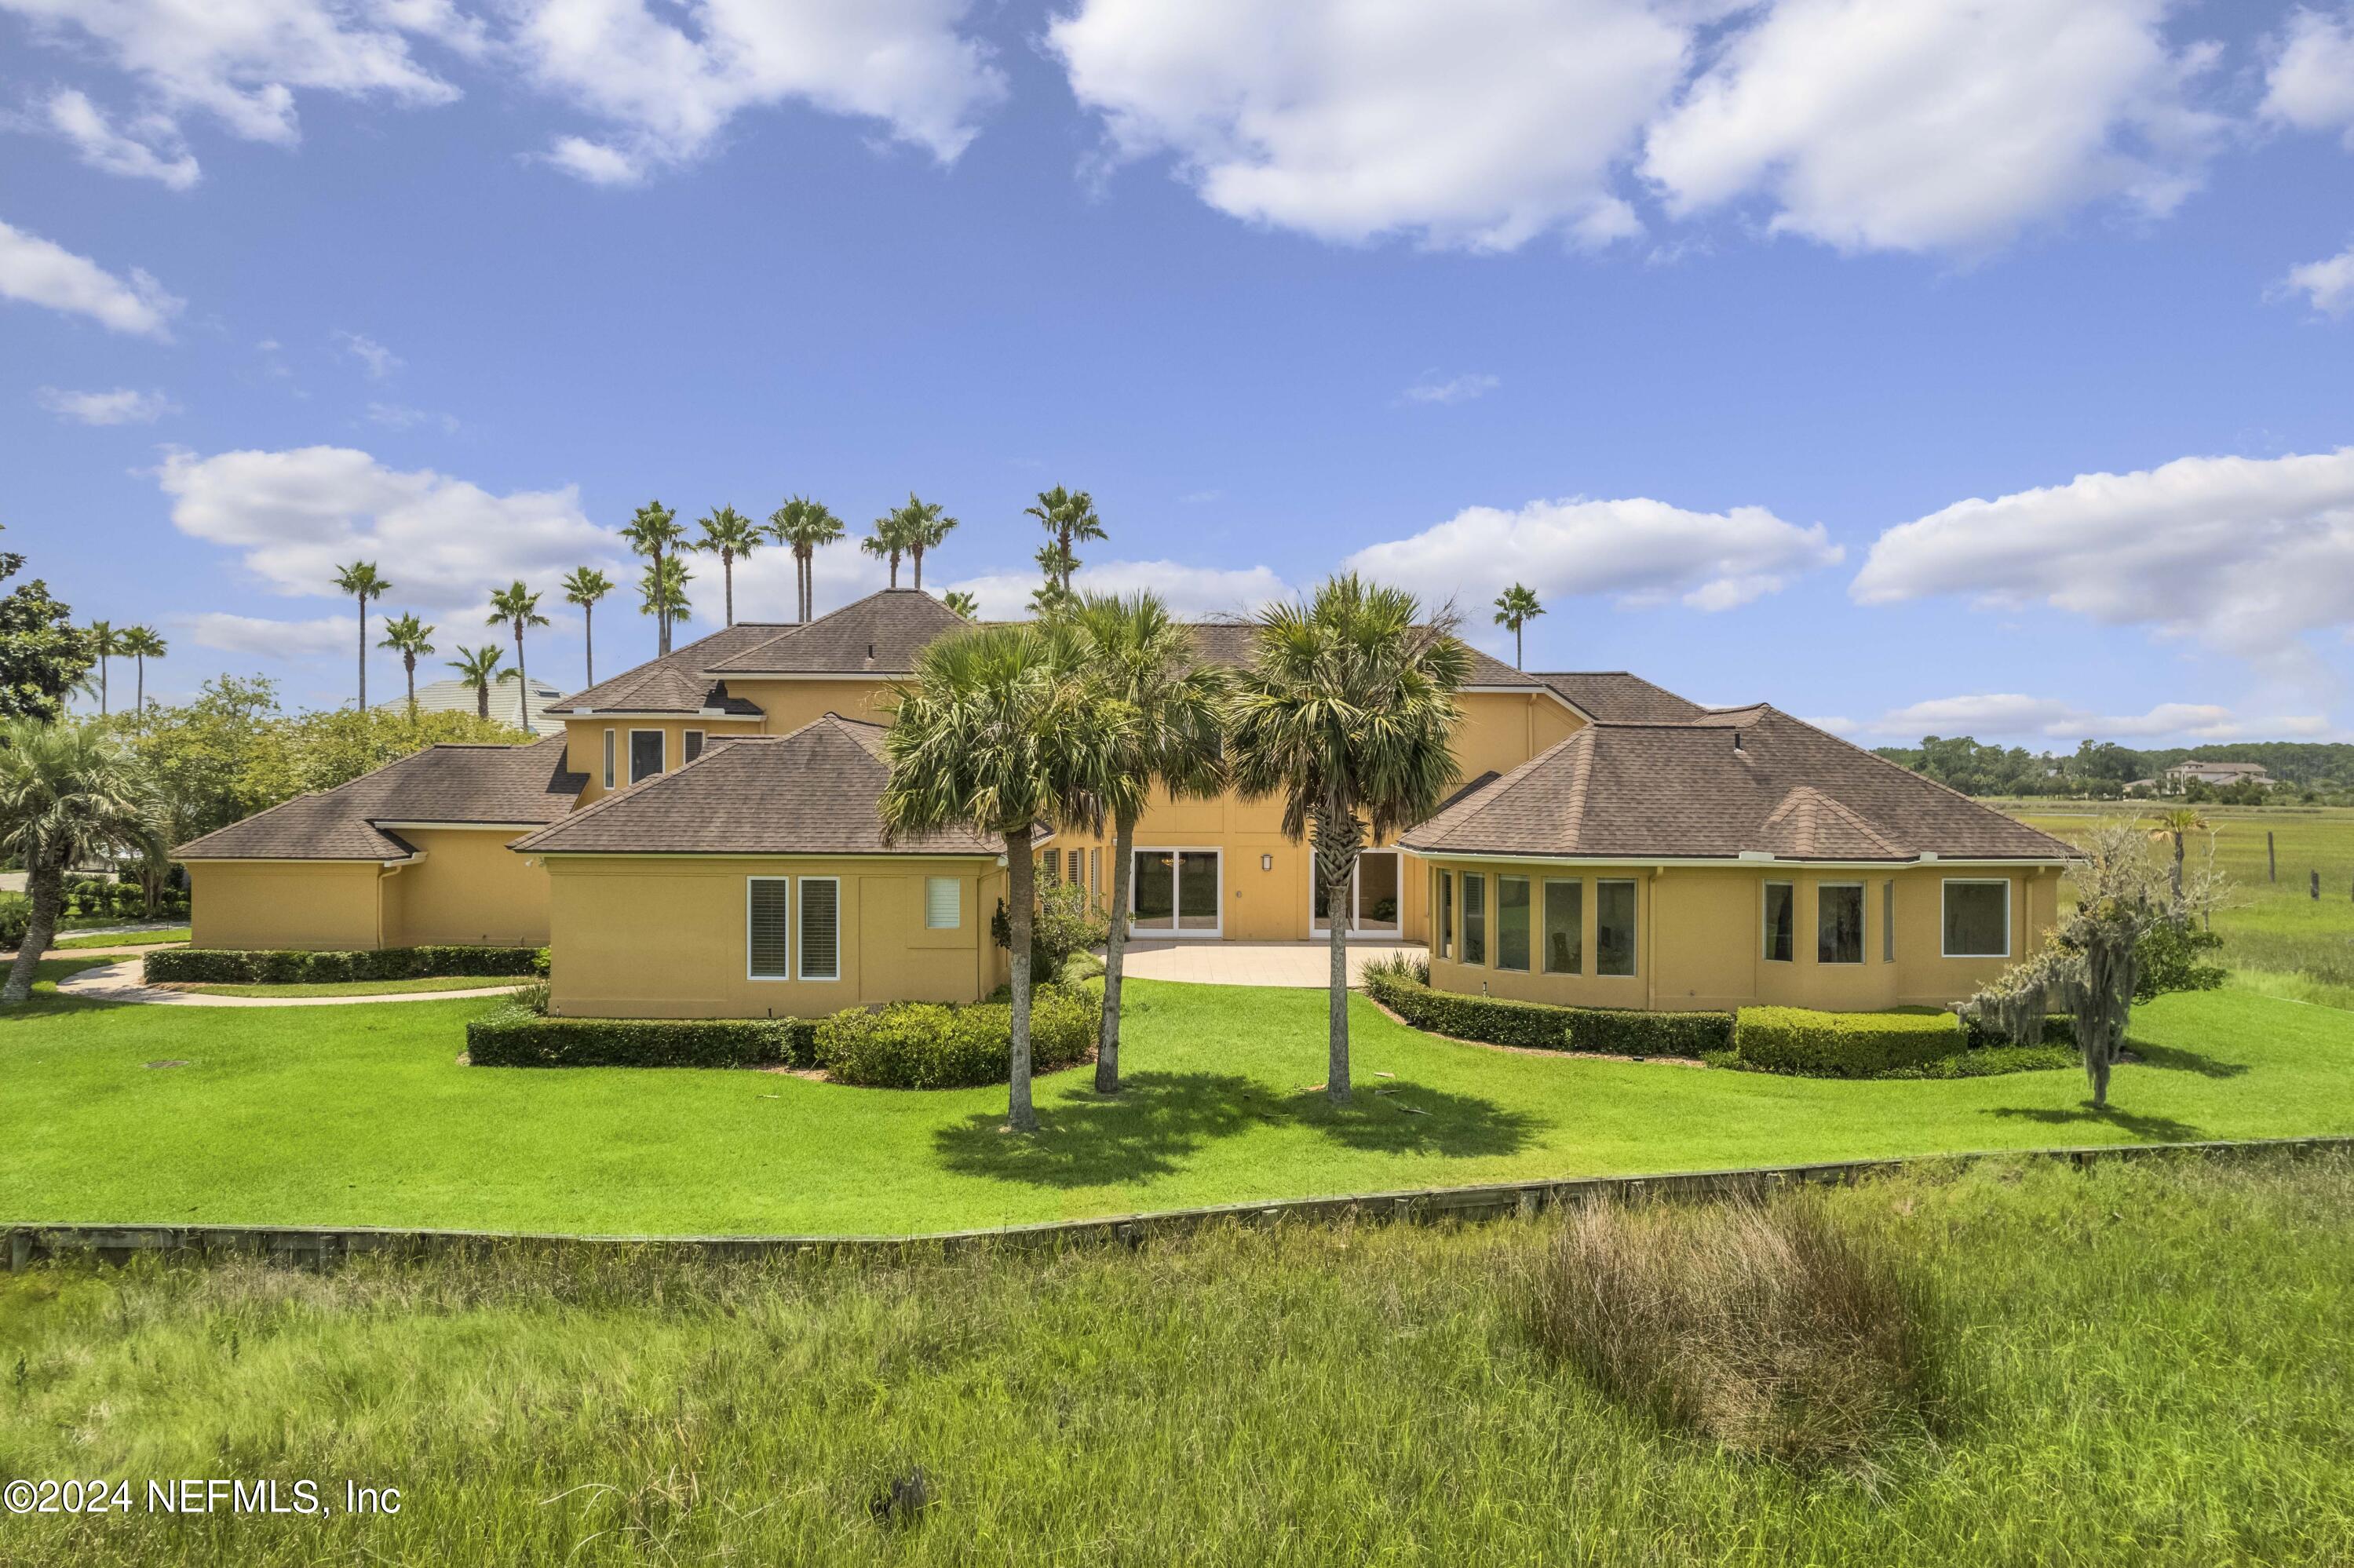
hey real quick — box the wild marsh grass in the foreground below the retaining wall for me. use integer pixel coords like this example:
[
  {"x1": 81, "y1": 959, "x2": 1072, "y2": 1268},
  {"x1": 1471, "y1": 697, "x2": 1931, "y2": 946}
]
[{"x1": 0, "y1": 1149, "x2": 2354, "y2": 1568}]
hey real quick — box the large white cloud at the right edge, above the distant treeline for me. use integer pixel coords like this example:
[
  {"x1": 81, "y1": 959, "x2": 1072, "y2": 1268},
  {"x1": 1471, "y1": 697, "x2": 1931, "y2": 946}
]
[{"x1": 1850, "y1": 447, "x2": 2354, "y2": 659}]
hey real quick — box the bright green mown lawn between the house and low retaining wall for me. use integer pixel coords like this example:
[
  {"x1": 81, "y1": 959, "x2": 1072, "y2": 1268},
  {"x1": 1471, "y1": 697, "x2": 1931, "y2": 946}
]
[{"x1": 0, "y1": 982, "x2": 2354, "y2": 1234}]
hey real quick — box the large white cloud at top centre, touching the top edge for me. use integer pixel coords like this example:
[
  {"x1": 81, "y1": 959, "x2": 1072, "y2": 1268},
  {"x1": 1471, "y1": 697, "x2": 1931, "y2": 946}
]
[{"x1": 1048, "y1": 0, "x2": 1690, "y2": 250}]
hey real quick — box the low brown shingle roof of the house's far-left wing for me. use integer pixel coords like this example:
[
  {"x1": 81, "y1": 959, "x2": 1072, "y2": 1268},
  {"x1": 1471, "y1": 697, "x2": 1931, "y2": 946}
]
[{"x1": 172, "y1": 735, "x2": 589, "y2": 859}]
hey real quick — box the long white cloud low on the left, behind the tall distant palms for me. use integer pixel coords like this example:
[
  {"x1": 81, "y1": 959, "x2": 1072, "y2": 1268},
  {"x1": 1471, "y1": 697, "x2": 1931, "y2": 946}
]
[{"x1": 158, "y1": 447, "x2": 636, "y2": 610}]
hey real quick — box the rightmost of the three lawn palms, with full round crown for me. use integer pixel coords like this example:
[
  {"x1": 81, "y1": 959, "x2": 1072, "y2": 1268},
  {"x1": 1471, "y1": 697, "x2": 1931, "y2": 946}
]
[{"x1": 1226, "y1": 572, "x2": 1471, "y2": 1104}]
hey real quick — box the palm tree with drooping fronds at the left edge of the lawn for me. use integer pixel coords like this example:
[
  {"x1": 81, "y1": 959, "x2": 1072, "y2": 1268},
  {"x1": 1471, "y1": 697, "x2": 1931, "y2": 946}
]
[{"x1": 0, "y1": 718, "x2": 165, "y2": 1003}]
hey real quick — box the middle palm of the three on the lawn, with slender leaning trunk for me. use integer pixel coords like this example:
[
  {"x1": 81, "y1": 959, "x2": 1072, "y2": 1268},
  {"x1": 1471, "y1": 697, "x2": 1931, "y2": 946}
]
[{"x1": 1074, "y1": 593, "x2": 1226, "y2": 1095}]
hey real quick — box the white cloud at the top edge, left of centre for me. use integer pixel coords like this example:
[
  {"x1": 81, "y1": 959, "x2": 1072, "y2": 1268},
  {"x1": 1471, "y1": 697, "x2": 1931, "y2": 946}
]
[{"x1": 506, "y1": 0, "x2": 1005, "y2": 184}]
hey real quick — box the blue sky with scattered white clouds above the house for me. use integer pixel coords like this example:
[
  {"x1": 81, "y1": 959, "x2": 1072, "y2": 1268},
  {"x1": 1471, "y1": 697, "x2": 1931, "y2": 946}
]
[{"x1": 0, "y1": 0, "x2": 2354, "y2": 746}]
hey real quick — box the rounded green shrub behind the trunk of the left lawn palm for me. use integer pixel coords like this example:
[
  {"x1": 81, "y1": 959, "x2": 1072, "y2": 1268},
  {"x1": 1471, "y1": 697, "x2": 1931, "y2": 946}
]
[{"x1": 817, "y1": 986, "x2": 1104, "y2": 1088}]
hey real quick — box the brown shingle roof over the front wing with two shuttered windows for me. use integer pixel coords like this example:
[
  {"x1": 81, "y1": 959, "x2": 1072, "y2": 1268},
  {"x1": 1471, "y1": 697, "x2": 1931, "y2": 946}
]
[{"x1": 509, "y1": 713, "x2": 1003, "y2": 855}]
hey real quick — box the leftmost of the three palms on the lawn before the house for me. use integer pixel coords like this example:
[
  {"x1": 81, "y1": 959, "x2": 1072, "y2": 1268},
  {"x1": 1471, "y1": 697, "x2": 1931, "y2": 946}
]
[{"x1": 878, "y1": 624, "x2": 1133, "y2": 1132}]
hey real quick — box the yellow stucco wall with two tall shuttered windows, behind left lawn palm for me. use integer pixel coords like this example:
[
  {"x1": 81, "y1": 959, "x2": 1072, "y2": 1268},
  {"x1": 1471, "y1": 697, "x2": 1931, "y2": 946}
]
[{"x1": 549, "y1": 855, "x2": 1005, "y2": 1017}]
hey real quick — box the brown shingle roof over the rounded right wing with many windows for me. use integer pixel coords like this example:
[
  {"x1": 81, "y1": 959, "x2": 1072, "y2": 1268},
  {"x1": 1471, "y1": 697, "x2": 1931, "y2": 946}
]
[{"x1": 1403, "y1": 706, "x2": 2069, "y2": 862}]
